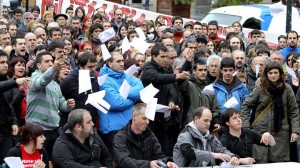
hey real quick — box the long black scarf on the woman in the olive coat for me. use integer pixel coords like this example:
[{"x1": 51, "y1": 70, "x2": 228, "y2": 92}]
[{"x1": 268, "y1": 83, "x2": 285, "y2": 133}]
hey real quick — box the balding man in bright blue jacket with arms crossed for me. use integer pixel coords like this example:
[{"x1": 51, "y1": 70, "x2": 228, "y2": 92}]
[{"x1": 99, "y1": 52, "x2": 144, "y2": 153}]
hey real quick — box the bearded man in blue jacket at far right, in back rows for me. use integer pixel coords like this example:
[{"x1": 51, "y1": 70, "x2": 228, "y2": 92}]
[{"x1": 280, "y1": 30, "x2": 300, "y2": 62}]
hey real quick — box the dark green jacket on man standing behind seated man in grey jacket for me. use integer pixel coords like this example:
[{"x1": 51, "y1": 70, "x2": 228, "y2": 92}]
[{"x1": 179, "y1": 78, "x2": 220, "y2": 124}]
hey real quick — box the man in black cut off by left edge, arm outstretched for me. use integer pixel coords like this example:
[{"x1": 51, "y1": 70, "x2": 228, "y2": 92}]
[{"x1": 0, "y1": 50, "x2": 29, "y2": 164}]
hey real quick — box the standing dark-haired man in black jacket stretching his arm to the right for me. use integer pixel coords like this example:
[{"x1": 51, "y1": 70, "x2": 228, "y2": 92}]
[{"x1": 141, "y1": 43, "x2": 190, "y2": 155}]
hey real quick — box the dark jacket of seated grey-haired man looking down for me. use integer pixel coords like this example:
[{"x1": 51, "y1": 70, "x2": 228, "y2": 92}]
[{"x1": 113, "y1": 121, "x2": 172, "y2": 168}]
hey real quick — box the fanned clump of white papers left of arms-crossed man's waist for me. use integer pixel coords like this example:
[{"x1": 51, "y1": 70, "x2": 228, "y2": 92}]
[{"x1": 85, "y1": 90, "x2": 110, "y2": 114}]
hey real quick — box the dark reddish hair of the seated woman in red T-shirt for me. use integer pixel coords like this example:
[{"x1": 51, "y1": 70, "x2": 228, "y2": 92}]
[{"x1": 20, "y1": 123, "x2": 44, "y2": 147}]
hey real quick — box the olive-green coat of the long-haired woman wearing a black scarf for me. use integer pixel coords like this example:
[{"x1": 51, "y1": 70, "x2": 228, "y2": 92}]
[{"x1": 241, "y1": 84, "x2": 300, "y2": 133}]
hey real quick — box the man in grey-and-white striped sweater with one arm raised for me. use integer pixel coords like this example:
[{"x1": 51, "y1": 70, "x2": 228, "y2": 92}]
[{"x1": 26, "y1": 52, "x2": 75, "y2": 160}]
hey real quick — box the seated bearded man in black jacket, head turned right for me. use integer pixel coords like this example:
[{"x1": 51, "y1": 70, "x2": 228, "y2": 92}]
[{"x1": 52, "y1": 109, "x2": 112, "y2": 168}]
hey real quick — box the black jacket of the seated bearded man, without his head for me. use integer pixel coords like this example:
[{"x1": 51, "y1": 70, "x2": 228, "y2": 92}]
[{"x1": 52, "y1": 126, "x2": 112, "y2": 168}]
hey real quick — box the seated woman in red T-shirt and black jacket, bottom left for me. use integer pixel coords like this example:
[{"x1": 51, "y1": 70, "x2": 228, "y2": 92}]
[{"x1": 7, "y1": 123, "x2": 49, "y2": 168}]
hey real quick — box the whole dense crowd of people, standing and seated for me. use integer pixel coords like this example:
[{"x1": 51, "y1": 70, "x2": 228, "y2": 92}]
[{"x1": 0, "y1": 4, "x2": 300, "y2": 168}]
